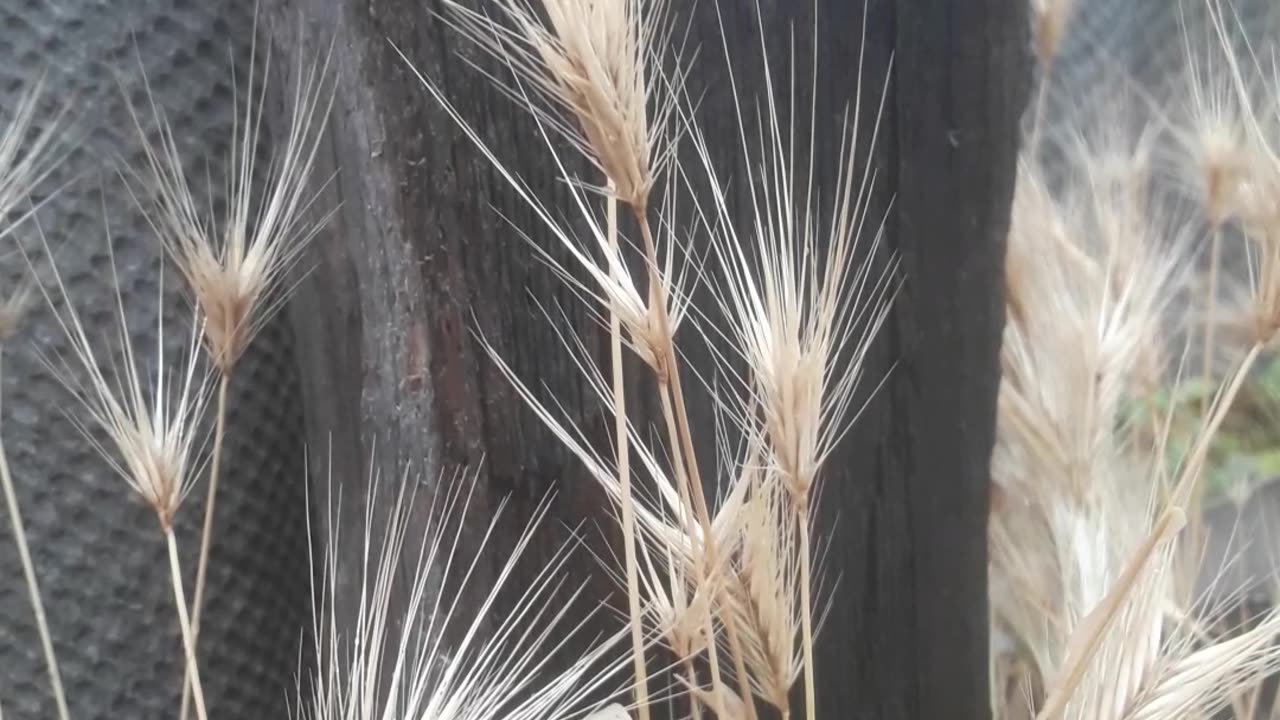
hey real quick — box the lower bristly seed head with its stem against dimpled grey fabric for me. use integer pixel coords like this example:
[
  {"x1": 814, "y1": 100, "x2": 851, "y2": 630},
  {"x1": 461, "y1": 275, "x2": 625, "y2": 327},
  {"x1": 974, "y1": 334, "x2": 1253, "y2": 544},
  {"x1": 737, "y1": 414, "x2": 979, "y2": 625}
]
[{"x1": 19, "y1": 210, "x2": 211, "y2": 720}]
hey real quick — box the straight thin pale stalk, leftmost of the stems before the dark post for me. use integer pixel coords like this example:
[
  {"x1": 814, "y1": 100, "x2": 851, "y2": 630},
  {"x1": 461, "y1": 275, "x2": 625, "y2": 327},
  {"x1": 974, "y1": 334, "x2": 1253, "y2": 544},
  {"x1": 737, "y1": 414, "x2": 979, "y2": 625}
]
[{"x1": 605, "y1": 181, "x2": 649, "y2": 720}]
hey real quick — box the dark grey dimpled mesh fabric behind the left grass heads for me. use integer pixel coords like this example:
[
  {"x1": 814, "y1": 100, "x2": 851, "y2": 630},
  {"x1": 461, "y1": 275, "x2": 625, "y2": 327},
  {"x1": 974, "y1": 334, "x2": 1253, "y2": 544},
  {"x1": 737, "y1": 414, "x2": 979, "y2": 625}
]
[{"x1": 0, "y1": 0, "x2": 310, "y2": 720}]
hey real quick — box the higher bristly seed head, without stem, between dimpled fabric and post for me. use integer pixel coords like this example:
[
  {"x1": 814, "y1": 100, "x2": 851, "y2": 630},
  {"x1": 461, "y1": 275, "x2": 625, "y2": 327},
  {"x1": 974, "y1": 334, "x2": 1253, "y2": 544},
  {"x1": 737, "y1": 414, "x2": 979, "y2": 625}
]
[{"x1": 129, "y1": 28, "x2": 335, "y2": 374}]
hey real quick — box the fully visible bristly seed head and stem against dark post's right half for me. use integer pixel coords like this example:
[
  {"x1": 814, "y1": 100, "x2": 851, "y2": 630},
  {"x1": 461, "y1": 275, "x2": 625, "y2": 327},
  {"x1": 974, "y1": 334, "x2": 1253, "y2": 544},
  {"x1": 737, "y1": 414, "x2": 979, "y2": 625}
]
[{"x1": 689, "y1": 4, "x2": 896, "y2": 719}]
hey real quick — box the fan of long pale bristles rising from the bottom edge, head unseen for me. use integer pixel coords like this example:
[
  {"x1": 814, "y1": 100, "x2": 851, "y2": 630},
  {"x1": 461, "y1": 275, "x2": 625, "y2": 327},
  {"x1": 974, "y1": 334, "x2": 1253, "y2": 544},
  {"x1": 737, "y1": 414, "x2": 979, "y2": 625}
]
[{"x1": 292, "y1": 458, "x2": 630, "y2": 720}]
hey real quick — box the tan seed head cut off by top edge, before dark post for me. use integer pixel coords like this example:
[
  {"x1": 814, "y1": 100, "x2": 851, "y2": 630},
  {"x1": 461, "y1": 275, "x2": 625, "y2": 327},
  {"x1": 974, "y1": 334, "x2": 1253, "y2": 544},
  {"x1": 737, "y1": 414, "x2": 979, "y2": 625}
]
[{"x1": 445, "y1": 0, "x2": 681, "y2": 213}]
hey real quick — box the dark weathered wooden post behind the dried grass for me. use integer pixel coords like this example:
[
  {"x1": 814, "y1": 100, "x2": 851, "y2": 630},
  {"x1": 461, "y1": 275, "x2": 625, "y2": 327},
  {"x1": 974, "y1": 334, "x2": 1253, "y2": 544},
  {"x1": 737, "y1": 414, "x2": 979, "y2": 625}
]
[{"x1": 266, "y1": 0, "x2": 1028, "y2": 720}]
